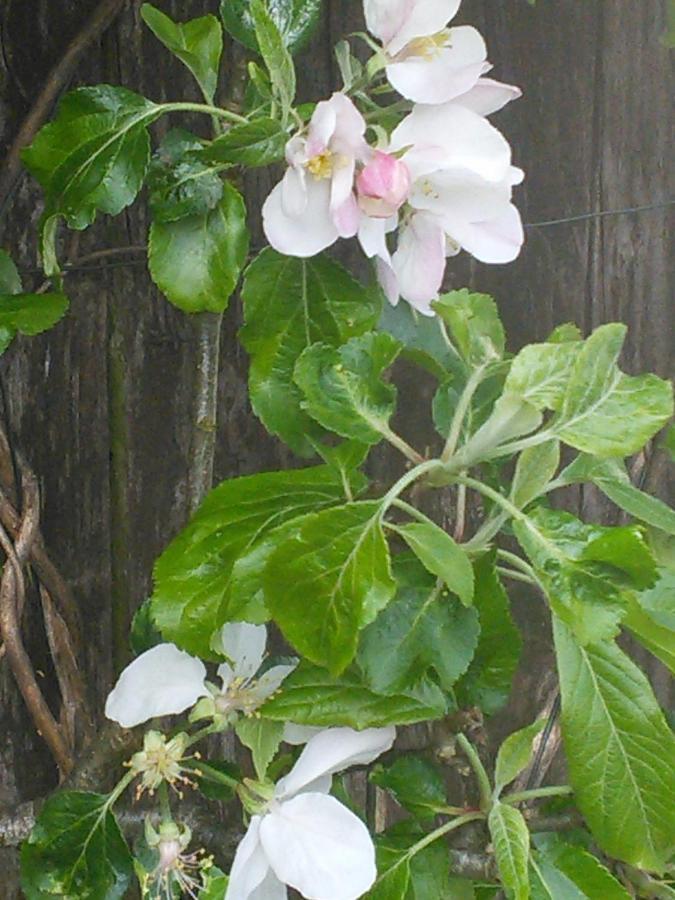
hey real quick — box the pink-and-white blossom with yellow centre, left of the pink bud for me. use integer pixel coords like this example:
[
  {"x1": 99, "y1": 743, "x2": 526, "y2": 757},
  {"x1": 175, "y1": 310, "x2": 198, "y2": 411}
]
[{"x1": 263, "y1": 93, "x2": 368, "y2": 257}]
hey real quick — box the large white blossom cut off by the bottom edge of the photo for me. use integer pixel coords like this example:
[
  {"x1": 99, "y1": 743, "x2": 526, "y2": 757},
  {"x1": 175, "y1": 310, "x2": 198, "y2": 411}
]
[{"x1": 225, "y1": 727, "x2": 396, "y2": 900}]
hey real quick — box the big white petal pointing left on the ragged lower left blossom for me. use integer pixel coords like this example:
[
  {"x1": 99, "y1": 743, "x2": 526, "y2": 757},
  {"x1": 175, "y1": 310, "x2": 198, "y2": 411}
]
[{"x1": 105, "y1": 644, "x2": 208, "y2": 728}]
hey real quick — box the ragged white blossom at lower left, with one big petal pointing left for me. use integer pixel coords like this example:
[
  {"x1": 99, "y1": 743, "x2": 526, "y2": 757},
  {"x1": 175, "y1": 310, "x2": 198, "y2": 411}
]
[{"x1": 105, "y1": 622, "x2": 295, "y2": 728}]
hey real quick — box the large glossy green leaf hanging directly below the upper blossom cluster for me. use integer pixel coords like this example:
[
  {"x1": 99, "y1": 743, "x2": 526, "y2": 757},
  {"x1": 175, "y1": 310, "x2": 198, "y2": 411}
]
[{"x1": 240, "y1": 249, "x2": 381, "y2": 456}]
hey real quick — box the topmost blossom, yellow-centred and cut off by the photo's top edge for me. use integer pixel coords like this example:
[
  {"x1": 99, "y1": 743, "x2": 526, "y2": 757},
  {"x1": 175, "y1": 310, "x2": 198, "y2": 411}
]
[{"x1": 364, "y1": 0, "x2": 487, "y2": 104}]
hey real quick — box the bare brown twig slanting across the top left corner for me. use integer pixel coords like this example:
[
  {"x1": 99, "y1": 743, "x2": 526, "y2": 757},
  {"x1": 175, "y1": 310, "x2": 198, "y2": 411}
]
[{"x1": 0, "y1": 0, "x2": 126, "y2": 214}]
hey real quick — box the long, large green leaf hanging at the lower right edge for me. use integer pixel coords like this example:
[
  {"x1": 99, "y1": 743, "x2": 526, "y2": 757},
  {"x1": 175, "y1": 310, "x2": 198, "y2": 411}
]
[{"x1": 554, "y1": 619, "x2": 675, "y2": 872}]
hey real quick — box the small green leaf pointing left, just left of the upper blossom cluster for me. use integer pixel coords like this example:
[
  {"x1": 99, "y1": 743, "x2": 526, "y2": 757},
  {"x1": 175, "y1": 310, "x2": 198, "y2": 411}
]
[{"x1": 200, "y1": 119, "x2": 288, "y2": 169}]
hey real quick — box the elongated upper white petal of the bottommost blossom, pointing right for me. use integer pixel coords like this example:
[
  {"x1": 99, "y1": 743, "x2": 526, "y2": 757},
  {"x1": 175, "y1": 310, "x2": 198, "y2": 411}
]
[{"x1": 275, "y1": 727, "x2": 396, "y2": 800}]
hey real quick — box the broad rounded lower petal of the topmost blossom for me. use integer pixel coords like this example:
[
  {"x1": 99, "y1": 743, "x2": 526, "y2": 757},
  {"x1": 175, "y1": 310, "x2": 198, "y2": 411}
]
[{"x1": 387, "y1": 25, "x2": 487, "y2": 104}]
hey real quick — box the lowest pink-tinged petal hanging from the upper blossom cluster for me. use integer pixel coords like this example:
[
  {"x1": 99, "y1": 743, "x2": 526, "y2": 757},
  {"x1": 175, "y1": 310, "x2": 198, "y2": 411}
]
[{"x1": 393, "y1": 214, "x2": 445, "y2": 316}]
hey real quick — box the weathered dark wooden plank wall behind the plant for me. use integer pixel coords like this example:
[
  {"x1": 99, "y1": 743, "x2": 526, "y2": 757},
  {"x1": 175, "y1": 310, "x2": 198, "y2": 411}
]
[{"x1": 0, "y1": 0, "x2": 675, "y2": 898}]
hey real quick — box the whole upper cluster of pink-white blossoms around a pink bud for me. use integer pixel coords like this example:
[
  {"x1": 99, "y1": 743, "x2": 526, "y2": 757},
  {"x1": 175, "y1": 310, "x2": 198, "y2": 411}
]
[{"x1": 263, "y1": 0, "x2": 524, "y2": 315}]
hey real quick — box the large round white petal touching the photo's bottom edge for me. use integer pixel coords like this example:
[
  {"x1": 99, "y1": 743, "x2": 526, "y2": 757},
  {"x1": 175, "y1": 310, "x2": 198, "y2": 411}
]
[{"x1": 260, "y1": 794, "x2": 377, "y2": 900}]
